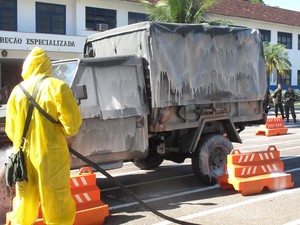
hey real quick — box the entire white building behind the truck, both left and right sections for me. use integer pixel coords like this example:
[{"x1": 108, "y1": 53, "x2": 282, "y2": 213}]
[{"x1": 0, "y1": 0, "x2": 300, "y2": 101}]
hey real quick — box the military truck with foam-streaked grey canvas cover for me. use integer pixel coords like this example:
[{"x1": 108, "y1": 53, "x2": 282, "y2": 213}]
[{"x1": 53, "y1": 22, "x2": 266, "y2": 184}]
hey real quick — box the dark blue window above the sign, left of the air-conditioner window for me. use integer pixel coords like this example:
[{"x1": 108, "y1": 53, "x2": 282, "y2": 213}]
[{"x1": 36, "y1": 2, "x2": 66, "y2": 34}]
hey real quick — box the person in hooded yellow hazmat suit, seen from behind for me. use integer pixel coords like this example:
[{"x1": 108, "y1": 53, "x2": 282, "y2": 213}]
[{"x1": 6, "y1": 47, "x2": 81, "y2": 225}]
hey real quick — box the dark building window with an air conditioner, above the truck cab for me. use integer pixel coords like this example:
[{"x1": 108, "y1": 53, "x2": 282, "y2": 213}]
[{"x1": 85, "y1": 7, "x2": 117, "y2": 30}]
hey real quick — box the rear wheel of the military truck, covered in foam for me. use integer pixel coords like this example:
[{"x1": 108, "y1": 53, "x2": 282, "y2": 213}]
[{"x1": 192, "y1": 134, "x2": 233, "y2": 185}]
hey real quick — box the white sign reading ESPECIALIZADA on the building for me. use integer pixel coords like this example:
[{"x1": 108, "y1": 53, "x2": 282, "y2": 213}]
[{"x1": 0, "y1": 31, "x2": 86, "y2": 53}]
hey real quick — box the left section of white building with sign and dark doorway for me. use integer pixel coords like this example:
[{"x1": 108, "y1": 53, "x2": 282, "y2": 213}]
[{"x1": 0, "y1": 0, "x2": 146, "y2": 102}]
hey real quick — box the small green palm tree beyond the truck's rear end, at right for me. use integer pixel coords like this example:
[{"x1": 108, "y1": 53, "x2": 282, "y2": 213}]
[{"x1": 264, "y1": 42, "x2": 292, "y2": 76}]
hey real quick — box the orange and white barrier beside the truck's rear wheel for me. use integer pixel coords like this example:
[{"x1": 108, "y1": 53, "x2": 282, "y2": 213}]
[{"x1": 218, "y1": 146, "x2": 294, "y2": 195}]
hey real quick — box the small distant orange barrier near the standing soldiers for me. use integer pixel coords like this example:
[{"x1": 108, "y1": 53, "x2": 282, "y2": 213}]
[{"x1": 256, "y1": 116, "x2": 288, "y2": 137}]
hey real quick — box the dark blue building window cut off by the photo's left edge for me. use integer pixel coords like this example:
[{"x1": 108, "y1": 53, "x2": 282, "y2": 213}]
[{"x1": 0, "y1": 0, "x2": 17, "y2": 31}]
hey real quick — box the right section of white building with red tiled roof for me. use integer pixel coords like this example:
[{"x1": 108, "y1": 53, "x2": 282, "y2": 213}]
[{"x1": 211, "y1": 0, "x2": 300, "y2": 89}]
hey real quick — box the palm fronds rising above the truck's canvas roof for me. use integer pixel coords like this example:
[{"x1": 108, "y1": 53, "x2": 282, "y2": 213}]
[{"x1": 141, "y1": 0, "x2": 219, "y2": 23}]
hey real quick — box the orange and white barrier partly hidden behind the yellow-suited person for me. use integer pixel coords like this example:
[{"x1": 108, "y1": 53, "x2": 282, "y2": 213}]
[{"x1": 34, "y1": 167, "x2": 109, "y2": 225}]
